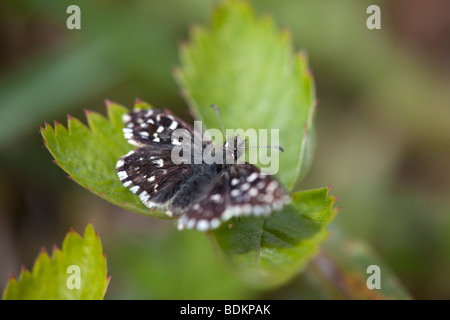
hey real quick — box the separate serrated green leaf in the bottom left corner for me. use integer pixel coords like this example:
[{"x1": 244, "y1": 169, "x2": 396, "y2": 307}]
[{"x1": 3, "y1": 224, "x2": 109, "y2": 300}]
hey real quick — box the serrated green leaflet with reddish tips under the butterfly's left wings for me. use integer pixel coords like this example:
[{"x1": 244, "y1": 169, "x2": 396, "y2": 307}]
[{"x1": 41, "y1": 101, "x2": 168, "y2": 219}]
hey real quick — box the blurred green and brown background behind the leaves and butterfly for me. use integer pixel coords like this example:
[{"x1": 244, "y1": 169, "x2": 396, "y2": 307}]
[{"x1": 0, "y1": 0, "x2": 450, "y2": 299}]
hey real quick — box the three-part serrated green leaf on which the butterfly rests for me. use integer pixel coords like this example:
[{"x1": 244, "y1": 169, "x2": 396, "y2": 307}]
[{"x1": 5, "y1": 0, "x2": 412, "y2": 297}]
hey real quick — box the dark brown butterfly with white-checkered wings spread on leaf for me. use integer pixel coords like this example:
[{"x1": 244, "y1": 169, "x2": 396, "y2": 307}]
[{"x1": 116, "y1": 105, "x2": 289, "y2": 231}]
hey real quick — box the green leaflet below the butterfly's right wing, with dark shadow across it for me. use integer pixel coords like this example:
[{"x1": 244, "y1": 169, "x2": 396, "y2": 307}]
[{"x1": 212, "y1": 188, "x2": 336, "y2": 287}]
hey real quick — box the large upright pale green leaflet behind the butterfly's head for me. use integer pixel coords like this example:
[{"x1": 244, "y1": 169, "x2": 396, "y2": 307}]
[{"x1": 175, "y1": 0, "x2": 316, "y2": 190}]
